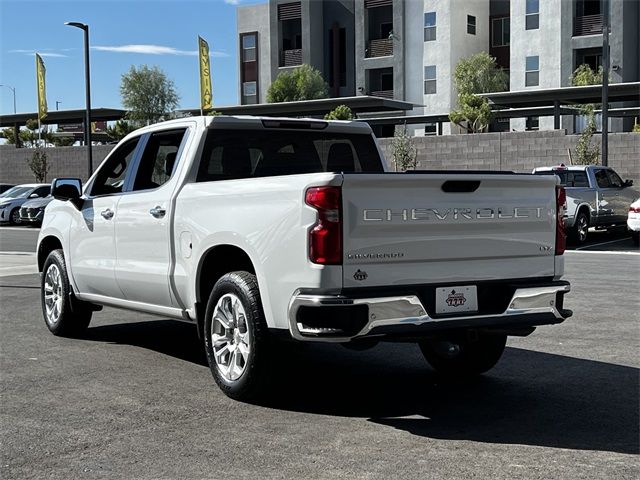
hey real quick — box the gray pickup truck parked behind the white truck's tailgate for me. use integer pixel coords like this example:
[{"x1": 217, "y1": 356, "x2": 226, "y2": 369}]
[{"x1": 533, "y1": 165, "x2": 640, "y2": 245}]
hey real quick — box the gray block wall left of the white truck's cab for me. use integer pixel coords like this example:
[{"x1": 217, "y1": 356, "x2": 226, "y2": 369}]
[{"x1": 0, "y1": 145, "x2": 115, "y2": 184}]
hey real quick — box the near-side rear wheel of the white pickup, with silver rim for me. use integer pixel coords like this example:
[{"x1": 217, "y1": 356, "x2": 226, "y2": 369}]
[{"x1": 204, "y1": 272, "x2": 270, "y2": 400}]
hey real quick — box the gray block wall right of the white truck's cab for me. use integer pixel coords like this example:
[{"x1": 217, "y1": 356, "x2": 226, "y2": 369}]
[{"x1": 379, "y1": 130, "x2": 640, "y2": 185}]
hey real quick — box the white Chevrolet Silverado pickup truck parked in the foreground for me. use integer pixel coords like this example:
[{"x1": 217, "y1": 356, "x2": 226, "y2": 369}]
[{"x1": 37, "y1": 117, "x2": 571, "y2": 399}]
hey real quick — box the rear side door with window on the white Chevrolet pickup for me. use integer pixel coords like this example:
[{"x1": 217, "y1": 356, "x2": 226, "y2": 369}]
[{"x1": 115, "y1": 128, "x2": 187, "y2": 307}]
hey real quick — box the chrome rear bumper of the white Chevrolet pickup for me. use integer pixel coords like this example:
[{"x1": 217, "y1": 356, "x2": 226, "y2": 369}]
[{"x1": 289, "y1": 285, "x2": 571, "y2": 342}]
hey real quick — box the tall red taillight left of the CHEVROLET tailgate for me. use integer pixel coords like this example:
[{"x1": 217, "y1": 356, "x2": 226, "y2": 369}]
[{"x1": 305, "y1": 187, "x2": 342, "y2": 265}]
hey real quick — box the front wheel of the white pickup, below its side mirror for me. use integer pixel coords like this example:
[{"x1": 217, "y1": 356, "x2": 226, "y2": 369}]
[{"x1": 40, "y1": 250, "x2": 92, "y2": 337}]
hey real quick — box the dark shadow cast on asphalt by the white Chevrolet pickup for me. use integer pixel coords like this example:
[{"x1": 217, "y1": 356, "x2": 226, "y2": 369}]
[{"x1": 88, "y1": 321, "x2": 640, "y2": 454}]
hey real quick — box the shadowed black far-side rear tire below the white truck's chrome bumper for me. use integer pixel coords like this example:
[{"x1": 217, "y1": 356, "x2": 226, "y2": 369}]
[{"x1": 418, "y1": 334, "x2": 507, "y2": 377}]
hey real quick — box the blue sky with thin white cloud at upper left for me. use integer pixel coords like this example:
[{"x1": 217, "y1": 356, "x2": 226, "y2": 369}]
[{"x1": 0, "y1": 0, "x2": 265, "y2": 114}]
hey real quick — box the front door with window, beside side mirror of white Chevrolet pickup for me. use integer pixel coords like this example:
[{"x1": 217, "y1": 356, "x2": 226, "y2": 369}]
[{"x1": 69, "y1": 138, "x2": 139, "y2": 298}]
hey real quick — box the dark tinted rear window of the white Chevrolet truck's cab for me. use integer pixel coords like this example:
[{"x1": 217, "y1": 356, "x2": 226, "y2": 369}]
[{"x1": 197, "y1": 129, "x2": 383, "y2": 182}]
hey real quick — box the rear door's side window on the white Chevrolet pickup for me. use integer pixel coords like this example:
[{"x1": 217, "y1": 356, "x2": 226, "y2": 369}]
[{"x1": 133, "y1": 128, "x2": 187, "y2": 190}]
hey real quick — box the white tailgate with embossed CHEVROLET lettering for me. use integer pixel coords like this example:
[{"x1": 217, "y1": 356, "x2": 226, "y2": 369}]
[{"x1": 342, "y1": 172, "x2": 556, "y2": 287}]
